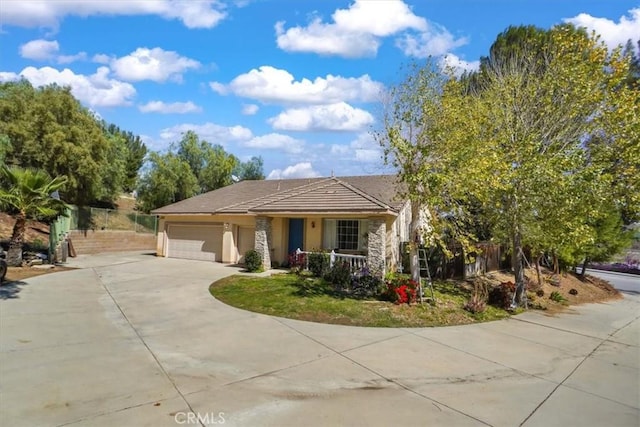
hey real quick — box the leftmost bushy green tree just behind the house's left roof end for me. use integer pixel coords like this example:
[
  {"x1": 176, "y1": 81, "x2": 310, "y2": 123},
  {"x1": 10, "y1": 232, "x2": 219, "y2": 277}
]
[{"x1": 138, "y1": 152, "x2": 199, "y2": 212}]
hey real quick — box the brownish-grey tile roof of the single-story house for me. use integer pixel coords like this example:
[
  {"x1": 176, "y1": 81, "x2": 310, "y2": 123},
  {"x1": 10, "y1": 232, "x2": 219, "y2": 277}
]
[{"x1": 153, "y1": 175, "x2": 404, "y2": 215}]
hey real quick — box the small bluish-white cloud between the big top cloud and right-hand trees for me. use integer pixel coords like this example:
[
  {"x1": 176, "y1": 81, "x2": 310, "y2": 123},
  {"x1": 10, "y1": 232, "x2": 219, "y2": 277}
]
[{"x1": 396, "y1": 24, "x2": 468, "y2": 58}]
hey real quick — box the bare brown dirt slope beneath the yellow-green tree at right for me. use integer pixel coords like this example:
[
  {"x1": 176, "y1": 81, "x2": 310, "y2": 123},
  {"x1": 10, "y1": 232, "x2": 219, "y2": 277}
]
[{"x1": 486, "y1": 269, "x2": 622, "y2": 314}]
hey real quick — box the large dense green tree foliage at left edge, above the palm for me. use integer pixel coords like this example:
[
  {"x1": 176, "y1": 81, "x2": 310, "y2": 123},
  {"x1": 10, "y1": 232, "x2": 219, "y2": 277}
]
[{"x1": 0, "y1": 80, "x2": 144, "y2": 205}]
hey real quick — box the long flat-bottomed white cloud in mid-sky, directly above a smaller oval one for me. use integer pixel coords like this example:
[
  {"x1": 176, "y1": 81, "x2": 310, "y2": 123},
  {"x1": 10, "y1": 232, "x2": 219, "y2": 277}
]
[{"x1": 210, "y1": 65, "x2": 383, "y2": 104}]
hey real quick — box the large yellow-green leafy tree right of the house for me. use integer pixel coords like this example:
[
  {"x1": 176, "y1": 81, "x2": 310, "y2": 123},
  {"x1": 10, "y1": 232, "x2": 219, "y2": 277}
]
[{"x1": 378, "y1": 26, "x2": 639, "y2": 299}]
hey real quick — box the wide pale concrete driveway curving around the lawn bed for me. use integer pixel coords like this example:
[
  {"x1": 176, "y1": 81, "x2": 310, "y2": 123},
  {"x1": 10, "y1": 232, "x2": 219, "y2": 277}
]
[{"x1": 0, "y1": 253, "x2": 640, "y2": 426}]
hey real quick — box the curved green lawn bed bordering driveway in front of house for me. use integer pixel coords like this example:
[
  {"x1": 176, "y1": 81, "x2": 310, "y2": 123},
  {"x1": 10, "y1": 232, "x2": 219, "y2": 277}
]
[{"x1": 210, "y1": 274, "x2": 510, "y2": 327}]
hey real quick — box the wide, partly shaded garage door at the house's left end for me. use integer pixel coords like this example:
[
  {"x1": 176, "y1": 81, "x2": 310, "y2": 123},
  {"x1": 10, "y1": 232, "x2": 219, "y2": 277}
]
[{"x1": 167, "y1": 224, "x2": 222, "y2": 261}]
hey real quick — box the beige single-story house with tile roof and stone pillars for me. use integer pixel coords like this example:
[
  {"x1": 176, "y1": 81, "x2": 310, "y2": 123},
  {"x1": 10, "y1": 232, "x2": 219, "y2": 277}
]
[{"x1": 152, "y1": 175, "x2": 411, "y2": 269}]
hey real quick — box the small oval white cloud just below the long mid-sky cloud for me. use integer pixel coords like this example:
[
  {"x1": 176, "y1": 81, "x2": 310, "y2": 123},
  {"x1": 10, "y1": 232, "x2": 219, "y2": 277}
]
[{"x1": 269, "y1": 102, "x2": 373, "y2": 131}]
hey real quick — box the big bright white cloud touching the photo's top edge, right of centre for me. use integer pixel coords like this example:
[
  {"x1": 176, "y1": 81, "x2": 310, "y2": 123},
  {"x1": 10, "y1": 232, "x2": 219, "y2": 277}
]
[{"x1": 275, "y1": 0, "x2": 427, "y2": 58}]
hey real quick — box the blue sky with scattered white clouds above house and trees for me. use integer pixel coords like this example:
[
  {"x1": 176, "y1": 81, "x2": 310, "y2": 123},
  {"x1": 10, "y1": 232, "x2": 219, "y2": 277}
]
[{"x1": 0, "y1": 0, "x2": 640, "y2": 178}]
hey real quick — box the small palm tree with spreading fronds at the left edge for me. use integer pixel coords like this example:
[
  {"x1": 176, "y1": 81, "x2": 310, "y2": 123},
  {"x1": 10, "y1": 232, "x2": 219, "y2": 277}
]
[{"x1": 0, "y1": 165, "x2": 67, "y2": 266}]
